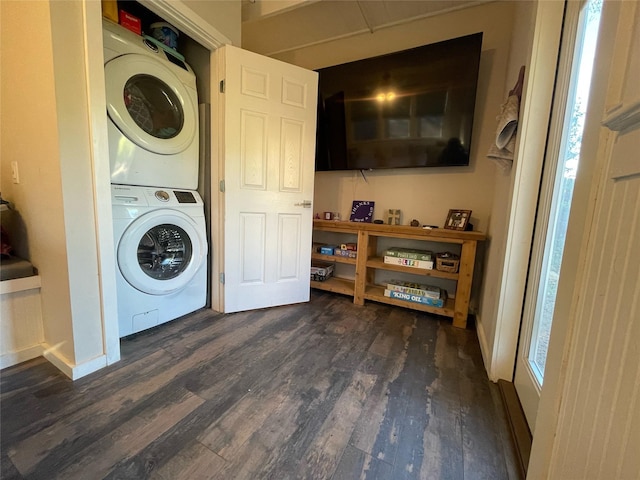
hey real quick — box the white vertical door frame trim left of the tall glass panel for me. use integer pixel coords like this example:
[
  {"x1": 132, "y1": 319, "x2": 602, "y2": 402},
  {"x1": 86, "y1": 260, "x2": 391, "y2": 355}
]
[{"x1": 488, "y1": 2, "x2": 564, "y2": 381}]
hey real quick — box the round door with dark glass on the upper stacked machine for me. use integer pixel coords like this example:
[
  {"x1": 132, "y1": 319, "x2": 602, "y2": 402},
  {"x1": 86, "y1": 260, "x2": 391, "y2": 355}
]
[{"x1": 105, "y1": 54, "x2": 198, "y2": 155}]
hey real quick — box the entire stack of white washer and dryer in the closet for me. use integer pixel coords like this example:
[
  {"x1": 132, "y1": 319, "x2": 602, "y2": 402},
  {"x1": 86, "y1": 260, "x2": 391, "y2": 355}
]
[{"x1": 103, "y1": 19, "x2": 208, "y2": 337}]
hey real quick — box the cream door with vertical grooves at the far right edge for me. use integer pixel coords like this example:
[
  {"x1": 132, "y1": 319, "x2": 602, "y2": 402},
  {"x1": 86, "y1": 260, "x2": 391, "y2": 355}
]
[{"x1": 528, "y1": 1, "x2": 640, "y2": 480}]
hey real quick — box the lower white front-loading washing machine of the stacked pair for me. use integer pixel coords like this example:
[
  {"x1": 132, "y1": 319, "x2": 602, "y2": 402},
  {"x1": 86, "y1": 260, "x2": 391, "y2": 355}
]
[{"x1": 111, "y1": 185, "x2": 207, "y2": 337}]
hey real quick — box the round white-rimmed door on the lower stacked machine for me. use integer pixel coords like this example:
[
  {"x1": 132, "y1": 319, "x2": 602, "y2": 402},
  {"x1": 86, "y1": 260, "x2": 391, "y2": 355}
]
[{"x1": 117, "y1": 209, "x2": 206, "y2": 295}]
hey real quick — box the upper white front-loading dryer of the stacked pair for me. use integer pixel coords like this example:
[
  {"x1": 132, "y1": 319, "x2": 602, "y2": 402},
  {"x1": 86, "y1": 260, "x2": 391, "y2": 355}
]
[{"x1": 103, "y1": 19, "x2": 199, "y2": 190}]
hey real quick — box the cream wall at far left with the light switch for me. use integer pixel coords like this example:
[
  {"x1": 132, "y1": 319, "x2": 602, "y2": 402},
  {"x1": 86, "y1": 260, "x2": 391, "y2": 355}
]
[{"x1": 0, "y1": 1, "x2": 75, "y2": 361}]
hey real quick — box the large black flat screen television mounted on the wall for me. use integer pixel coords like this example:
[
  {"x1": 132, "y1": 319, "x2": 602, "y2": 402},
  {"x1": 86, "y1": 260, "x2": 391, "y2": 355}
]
[{"x1": 316, "y1": 33, "x2": 482, "y2": 171}]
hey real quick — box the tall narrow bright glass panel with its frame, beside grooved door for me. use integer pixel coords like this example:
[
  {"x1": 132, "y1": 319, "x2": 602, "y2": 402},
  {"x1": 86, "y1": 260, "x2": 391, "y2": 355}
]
[{"x1": 514, "y1": 0, "x2": 602, "y2": 432}]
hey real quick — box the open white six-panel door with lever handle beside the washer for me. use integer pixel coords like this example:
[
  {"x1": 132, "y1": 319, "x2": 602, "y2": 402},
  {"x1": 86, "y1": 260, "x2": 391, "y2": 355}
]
[{"x1": 217, "y1": 45, "x2": 318, "y2": 312}]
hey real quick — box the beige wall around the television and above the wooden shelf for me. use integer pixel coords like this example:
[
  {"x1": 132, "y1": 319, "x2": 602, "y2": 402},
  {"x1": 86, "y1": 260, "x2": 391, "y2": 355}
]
[{"x1": 274, "y1": 2, "x2": 515, "y2": 236}]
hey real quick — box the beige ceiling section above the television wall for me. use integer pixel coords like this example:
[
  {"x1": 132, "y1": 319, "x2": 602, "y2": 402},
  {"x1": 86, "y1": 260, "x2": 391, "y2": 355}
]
[{"x1": 242, "y1": 0, "x2": 491, "y2": 56}]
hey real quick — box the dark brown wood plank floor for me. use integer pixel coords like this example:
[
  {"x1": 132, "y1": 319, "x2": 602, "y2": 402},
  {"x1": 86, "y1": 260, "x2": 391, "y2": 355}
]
[{"x1": 0, "y1": 291, "x2": 517, "y2": 480}]
